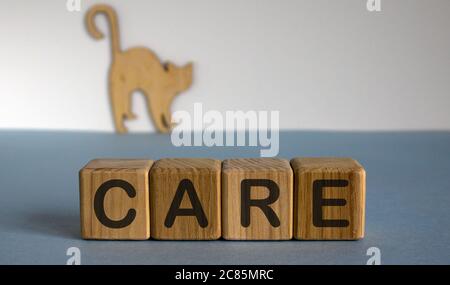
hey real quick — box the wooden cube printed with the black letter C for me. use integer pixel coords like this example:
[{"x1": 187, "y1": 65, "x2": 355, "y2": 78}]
[{"x1": 79, "y1": 159, "x2": 153, "y2": 240}]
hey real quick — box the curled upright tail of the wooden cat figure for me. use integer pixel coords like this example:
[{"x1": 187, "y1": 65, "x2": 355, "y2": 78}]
[{"x1": 86, "y1": 5, "x2": 120, "y2": 56}]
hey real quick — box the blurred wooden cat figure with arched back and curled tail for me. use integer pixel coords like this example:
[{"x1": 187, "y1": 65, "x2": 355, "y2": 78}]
[{"x1": 86, "y1": 5, "x2": 192, "y2": 133}]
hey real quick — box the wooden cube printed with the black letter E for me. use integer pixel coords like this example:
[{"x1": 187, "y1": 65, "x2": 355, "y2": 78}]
[{"x1": 291, "y1": 158, "x2": 366, "y2": 240}]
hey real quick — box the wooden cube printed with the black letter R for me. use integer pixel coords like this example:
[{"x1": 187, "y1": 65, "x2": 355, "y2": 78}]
[{"x1": 222, "y1": 158, "x2": 293, "y2": 240}]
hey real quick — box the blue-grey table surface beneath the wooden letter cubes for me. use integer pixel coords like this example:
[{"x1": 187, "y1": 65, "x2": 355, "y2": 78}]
[{"x1": 0, "y1": 131, "x2": 450, "y2": 264}]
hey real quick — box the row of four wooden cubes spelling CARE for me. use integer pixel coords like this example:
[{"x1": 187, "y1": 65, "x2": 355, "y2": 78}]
[{"x1": 79, "y1": 158, "x2": 366, "y2": 240}]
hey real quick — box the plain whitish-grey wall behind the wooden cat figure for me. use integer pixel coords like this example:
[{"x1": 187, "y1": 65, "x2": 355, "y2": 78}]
[{"x1": 0, "y1": 0, "x2": 450, "y2": 131}]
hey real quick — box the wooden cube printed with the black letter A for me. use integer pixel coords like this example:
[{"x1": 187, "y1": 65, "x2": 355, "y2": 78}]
[{"x1": 150, "y1": 158, "x2": 221, "y2": 240}]
